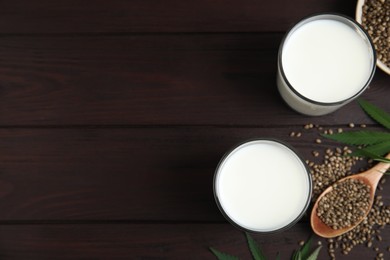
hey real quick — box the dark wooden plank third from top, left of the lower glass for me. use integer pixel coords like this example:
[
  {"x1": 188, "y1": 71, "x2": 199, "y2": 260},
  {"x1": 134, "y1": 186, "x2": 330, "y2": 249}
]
[{"x1": 0, "y1": 127, "x2": 390, "y2": 220}]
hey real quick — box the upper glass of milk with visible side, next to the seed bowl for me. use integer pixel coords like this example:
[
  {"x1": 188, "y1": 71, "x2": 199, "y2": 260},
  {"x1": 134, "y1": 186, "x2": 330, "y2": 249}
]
[{"x1": 277, "y1": 14, "x2": 376, "y2": 116}]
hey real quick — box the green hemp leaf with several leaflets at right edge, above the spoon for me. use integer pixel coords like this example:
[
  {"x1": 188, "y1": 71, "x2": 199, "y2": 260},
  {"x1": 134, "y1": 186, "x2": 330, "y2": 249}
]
[{"x1": 322, "y1": 99, "x2": 390, "y2": 161}]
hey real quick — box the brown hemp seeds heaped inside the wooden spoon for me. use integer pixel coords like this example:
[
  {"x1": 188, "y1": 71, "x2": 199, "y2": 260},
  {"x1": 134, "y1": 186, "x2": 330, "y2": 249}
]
[{"x1": 317, "y1": 179, "x2": 370, "y2": 229}]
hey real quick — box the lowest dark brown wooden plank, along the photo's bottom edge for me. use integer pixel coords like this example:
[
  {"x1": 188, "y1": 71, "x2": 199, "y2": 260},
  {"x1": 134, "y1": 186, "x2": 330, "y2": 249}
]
[{"x1": 0, "y1": 223, "x2": 390, "y2": 260}]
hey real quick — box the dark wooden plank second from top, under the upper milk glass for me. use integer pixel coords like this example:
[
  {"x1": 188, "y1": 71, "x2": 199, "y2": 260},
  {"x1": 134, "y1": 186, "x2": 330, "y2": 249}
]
[{"x1": 0, "y1": 33, "x2": 390, "y2": 126}]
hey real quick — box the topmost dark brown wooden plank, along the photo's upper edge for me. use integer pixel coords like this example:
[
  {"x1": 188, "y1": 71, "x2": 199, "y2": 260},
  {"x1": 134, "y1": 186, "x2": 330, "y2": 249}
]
[{"x1": 0, "y1": 0, "x2": 356, "y2": 34}]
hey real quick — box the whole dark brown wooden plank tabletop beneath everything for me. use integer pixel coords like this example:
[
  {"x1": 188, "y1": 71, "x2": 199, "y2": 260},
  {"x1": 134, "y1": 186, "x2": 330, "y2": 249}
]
[{"x1": 0, "y1": 0, "x2": 390, "y2": 259}]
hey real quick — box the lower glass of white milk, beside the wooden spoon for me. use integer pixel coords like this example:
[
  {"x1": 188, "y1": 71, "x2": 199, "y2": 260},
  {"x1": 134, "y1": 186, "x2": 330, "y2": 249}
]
[{"x1": 213, "y1": 139, "x2": 312, "y2": 233}]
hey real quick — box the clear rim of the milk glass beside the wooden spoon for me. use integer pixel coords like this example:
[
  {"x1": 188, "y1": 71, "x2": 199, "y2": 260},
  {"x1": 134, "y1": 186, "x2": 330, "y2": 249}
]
[{"x1": 213, "y1": 137, "x2": 313, "y2": 234}]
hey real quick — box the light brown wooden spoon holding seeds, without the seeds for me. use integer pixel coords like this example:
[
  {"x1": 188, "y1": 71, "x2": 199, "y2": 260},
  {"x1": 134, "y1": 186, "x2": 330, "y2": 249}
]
[{"x1": 310, "y1": 153, "x2": 390, "y2": 238}]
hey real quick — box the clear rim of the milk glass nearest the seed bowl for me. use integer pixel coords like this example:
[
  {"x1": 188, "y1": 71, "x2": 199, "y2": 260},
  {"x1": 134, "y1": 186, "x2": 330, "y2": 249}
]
[{"x1": 278, "y1": 12, "x2": 377, "y2": 107}]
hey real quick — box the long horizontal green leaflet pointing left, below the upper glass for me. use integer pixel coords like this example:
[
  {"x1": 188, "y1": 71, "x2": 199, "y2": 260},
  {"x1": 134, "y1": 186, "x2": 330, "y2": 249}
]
[{"x1": 322, "y1": 131, "x2": 390, "y2": 145}]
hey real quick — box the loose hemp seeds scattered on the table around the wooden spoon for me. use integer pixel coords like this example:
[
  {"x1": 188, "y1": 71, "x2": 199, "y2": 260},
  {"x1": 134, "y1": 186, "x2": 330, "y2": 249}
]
[{"x1": 290, "y1": 123, "x2": 390, "y2": 260}]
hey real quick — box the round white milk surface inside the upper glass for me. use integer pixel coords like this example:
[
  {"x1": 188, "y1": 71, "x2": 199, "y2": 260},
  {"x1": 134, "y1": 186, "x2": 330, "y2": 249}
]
[{"x1": 282, "y1": 19, "x2": 374, "y2": 103}]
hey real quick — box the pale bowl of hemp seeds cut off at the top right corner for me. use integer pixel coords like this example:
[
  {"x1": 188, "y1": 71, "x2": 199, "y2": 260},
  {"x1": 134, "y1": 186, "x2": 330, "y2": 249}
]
[{"x1": 355, "y1": 0, "x2": 390, "y2": 75}]
